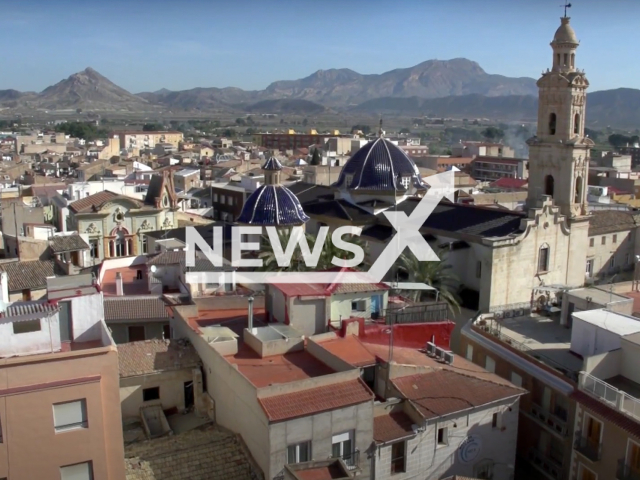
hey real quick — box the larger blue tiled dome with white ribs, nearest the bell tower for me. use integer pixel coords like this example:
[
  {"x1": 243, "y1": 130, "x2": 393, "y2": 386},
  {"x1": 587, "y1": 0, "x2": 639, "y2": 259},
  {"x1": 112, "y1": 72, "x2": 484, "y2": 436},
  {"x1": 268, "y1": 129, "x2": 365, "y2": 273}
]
[{"x1": 334, "y1": 137, "x2": 428, "y2": 191}]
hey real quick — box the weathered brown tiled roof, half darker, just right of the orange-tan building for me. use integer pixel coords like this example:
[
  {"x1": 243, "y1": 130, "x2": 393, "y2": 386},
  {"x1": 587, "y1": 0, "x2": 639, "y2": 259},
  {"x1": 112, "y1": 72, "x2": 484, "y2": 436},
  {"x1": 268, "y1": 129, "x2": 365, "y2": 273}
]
[{"x1": 118, "y1": 339, "x2": 200, "y2": 377}]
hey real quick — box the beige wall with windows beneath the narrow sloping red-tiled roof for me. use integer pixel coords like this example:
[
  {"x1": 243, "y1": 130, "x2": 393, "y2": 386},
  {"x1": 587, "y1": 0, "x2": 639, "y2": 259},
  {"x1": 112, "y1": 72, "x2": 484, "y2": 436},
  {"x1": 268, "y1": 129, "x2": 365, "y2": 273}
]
[{"x1": 265, "y1": 402, "x2": 373, "y2": 478}]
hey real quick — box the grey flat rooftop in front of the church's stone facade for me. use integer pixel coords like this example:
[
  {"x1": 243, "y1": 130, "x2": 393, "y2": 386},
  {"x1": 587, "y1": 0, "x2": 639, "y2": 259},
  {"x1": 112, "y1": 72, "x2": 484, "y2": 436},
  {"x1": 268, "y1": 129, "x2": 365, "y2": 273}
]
[{"x1": 494, "y1": 315, "x2": 582, "y2": 373}]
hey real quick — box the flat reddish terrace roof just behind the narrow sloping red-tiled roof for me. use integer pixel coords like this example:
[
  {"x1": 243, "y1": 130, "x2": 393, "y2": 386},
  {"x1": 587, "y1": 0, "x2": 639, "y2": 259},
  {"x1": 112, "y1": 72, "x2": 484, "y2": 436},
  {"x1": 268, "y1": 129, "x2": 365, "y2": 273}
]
[{"x1": 225, "y1": 342, "x2": 335, "y2": 388}]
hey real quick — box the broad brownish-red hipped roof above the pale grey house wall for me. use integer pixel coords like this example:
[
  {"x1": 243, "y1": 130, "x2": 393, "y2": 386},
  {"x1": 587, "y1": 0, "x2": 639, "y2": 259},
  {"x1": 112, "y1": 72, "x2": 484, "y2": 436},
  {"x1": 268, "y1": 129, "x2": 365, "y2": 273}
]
[{"x1": 392, "y1": 369, "x2": 526, "y2": 419}]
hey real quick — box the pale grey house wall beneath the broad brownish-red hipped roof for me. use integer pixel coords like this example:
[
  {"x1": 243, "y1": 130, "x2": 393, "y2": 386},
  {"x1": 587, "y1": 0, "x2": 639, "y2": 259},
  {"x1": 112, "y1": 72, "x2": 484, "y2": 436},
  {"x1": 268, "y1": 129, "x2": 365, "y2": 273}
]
[{"x1": 374, "y1": 399, "x2": 518, "y2": 480}]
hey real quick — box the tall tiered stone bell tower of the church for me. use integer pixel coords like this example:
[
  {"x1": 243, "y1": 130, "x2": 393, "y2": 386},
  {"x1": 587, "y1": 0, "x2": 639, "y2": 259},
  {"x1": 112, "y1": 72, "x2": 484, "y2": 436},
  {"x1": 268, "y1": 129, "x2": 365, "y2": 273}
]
[{"x1": 527, "y1": 15, "x2": 594, "y2": 220}]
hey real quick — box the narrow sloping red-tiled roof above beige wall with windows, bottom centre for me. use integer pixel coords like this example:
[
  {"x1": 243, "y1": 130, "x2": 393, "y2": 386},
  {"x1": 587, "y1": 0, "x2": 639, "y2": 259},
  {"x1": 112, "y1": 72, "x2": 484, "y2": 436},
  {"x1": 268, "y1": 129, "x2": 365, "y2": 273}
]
[{"x1": 258, "y1": 379, "x2": 373, "y2": 422}]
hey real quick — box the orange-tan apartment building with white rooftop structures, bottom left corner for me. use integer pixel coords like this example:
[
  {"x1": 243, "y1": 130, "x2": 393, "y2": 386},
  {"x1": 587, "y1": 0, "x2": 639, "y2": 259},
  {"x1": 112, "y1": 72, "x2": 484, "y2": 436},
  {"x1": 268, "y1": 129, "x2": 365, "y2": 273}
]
[{"x1": 0, "y1": 276, "x2": 125, "y2": 480}]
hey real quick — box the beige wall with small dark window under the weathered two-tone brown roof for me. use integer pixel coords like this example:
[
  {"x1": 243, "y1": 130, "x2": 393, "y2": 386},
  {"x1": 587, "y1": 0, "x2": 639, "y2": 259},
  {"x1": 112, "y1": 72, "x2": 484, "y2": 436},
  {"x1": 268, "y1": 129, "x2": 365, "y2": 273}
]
[{"x1": 120, "y1": 368, "x2": 193, "y2": 422}]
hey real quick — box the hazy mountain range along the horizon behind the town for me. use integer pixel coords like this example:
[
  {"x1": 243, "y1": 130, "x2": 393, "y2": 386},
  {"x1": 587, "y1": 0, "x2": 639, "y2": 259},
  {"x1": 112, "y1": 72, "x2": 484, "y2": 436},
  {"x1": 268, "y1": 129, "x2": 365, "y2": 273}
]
[{"x1": 0, "y1": 58, "x2": 640, "y2": 126}]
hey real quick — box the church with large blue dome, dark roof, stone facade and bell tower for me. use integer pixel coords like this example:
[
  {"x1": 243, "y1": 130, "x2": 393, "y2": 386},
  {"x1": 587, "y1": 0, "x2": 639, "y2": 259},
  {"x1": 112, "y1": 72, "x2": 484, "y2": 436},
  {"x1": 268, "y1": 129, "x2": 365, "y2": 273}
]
[{"x1": 295, "y1": 18, "x2": 593, "y2": 313}]
